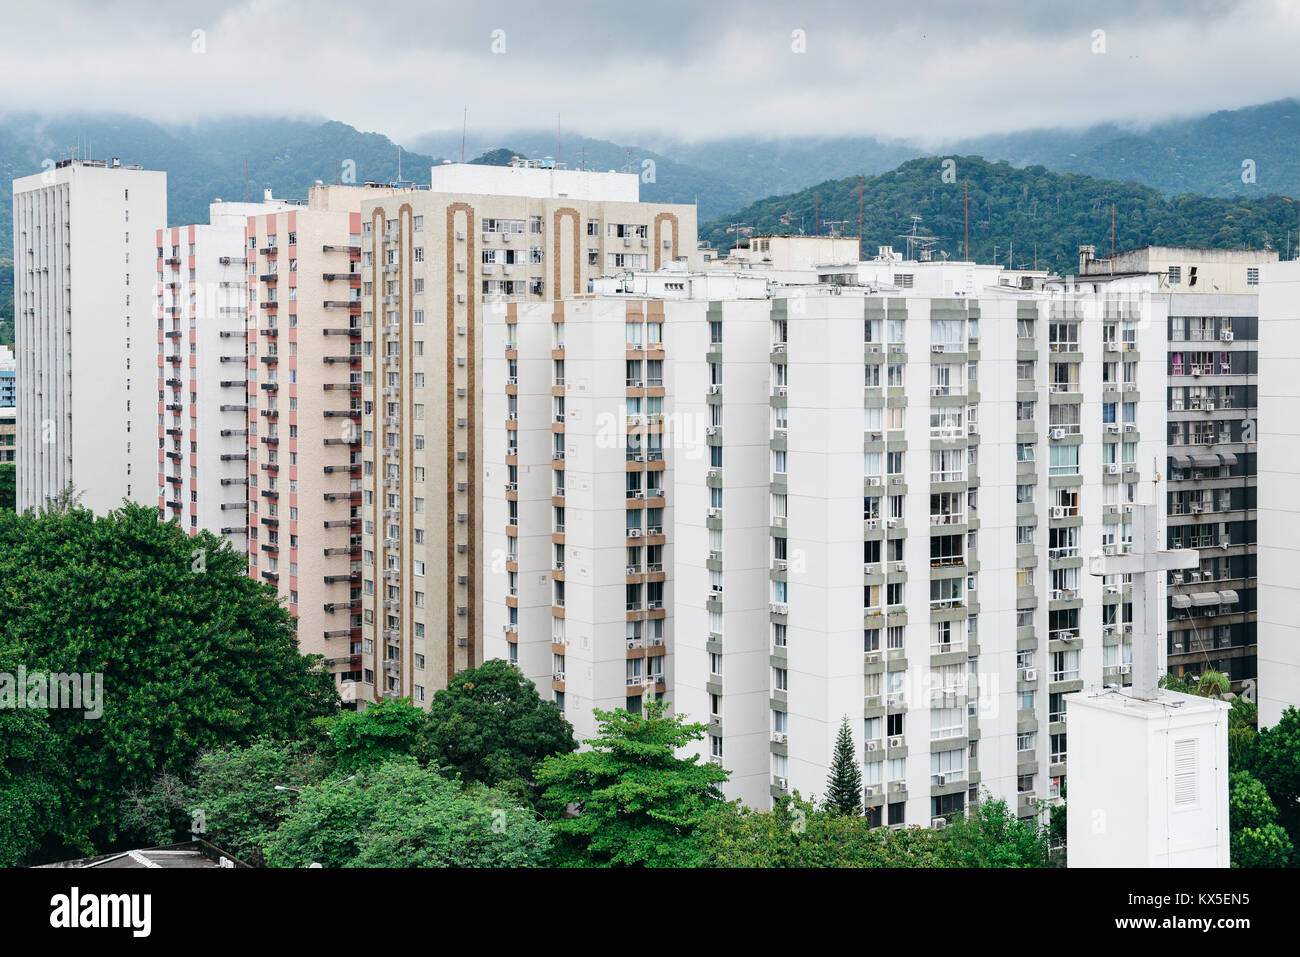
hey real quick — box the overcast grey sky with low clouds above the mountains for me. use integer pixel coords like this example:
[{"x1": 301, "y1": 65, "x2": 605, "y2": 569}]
[{"x1": 0, "y1": 0, "x2": 1300, "y2": 143}]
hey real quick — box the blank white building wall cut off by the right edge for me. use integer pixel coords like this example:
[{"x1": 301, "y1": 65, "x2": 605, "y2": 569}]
[{"x1": 1258, "y1": 260, "x2": 1300, "y2": 727}]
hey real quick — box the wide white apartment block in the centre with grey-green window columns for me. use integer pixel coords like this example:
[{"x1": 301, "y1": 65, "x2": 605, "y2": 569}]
[{"x1": 484, "y1": 239, "x2": 1166, "y2": 824}]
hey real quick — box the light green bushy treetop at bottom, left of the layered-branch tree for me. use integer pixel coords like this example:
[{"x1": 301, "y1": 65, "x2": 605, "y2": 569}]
[{"x1": 267, "y1": 757, "x2": 551, "y2": 867}]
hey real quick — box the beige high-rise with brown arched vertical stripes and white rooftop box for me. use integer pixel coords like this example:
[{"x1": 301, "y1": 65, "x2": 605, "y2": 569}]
[{"x1": 356, "y1": 163, "x2": 698, "y2": 703}]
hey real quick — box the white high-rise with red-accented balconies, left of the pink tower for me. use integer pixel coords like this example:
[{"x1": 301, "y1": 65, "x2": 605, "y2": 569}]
[{"x1": 155, "y1": 190, "x2": 294, "y2": 553}]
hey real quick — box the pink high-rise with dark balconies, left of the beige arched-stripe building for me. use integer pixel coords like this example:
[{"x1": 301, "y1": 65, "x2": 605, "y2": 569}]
[{"x1": 241, "y1": 186, "x2": 408, "y2": 696}]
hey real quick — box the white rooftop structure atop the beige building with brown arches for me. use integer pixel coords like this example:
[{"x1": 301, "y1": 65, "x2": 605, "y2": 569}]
[{"x1": 429, "y1": 160, "x2": 641, "y2": 203}]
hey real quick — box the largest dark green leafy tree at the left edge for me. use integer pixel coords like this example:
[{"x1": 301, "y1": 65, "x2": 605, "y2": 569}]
[{"x1": 0, "y1": 504, "x2": 338, "y2": 865}]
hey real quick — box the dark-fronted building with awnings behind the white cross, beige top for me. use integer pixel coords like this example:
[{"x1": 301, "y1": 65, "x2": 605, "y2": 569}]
[{"x1": 1079, "y1": 246, "x2": 1278, "y2": 690}]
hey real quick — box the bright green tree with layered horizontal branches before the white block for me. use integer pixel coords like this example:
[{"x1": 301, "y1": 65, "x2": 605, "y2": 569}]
[{"x1": 537, "y1": 702, "x2": 729, "y2": 867}]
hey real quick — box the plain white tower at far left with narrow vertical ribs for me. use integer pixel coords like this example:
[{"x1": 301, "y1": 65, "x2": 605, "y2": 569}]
[{"x1": 13, "y1": 159, "x2": 166, "y2": 512}]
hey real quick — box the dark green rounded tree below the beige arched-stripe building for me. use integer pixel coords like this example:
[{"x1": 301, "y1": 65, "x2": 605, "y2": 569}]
[{"x1": 416, "y1": 659, "x2": 577, "y2": 793}]
